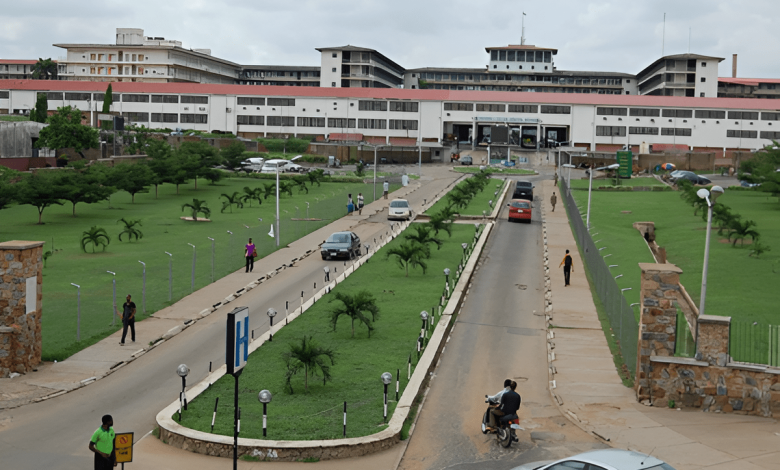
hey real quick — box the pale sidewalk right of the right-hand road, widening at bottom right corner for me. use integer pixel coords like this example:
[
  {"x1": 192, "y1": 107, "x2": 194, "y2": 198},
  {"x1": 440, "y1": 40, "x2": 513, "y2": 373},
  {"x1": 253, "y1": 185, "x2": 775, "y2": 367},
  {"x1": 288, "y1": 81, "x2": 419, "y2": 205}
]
[{"x1": 538, "y1": 180, "x2": 780, "y2": 470}]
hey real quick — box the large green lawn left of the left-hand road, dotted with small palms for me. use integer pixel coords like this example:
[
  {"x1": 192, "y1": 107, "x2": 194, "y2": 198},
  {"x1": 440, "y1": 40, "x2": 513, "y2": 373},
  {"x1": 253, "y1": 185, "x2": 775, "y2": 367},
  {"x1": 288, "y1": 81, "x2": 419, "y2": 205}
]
[{"x1": 0, "y1": 178, "x2": 398, "y2": 360}]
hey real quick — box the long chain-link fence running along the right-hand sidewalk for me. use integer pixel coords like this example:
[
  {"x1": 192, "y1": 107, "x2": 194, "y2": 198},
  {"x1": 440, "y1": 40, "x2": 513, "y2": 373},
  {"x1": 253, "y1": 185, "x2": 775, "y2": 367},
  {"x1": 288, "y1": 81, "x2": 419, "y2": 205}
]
[{"x1": 558, "y1": 178, "x2": 639, "y2": 377}]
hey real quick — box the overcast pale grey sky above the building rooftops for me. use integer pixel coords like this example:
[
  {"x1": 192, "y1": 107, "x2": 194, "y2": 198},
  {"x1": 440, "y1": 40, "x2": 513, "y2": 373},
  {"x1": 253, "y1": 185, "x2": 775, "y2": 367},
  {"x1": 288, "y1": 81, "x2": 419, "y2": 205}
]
[{"x1": 0, "y1": 0, "x2": 780, "y2": 78}]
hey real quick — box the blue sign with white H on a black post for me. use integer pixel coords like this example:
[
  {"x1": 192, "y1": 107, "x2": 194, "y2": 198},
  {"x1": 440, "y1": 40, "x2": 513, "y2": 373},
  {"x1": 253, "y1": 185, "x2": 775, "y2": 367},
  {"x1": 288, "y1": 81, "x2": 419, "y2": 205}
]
[{"x1": 225, "y1": 307, "x2": 249, "y2": 470}]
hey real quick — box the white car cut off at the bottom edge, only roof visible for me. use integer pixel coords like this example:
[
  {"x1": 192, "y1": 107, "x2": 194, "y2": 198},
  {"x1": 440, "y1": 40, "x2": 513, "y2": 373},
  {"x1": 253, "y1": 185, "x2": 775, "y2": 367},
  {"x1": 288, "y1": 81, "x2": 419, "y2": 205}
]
[{"x1": 512, "y1": 449, "x2": 674, "y2": 470}]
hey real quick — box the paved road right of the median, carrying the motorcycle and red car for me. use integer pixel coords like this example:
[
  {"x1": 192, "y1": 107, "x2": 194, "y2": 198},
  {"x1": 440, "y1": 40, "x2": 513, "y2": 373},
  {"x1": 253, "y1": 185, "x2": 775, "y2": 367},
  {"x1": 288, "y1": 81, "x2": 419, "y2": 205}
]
[{"x1": 399, "y1": 174, "x2": 603, "y2": 470}]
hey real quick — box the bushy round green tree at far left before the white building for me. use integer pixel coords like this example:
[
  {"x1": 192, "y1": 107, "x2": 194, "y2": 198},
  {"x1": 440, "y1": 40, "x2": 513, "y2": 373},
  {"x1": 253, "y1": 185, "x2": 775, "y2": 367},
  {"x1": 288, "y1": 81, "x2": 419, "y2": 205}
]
[{"x1": 35, "y1": 106, "x2": 98, "y2": 158}]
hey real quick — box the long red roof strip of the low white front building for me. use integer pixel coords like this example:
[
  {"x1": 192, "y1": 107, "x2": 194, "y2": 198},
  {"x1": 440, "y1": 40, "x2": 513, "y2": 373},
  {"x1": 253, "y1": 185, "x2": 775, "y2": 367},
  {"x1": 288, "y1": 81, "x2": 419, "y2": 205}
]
[{"x1": 0, "y1": 80, "x2": 780, "y2": 111}]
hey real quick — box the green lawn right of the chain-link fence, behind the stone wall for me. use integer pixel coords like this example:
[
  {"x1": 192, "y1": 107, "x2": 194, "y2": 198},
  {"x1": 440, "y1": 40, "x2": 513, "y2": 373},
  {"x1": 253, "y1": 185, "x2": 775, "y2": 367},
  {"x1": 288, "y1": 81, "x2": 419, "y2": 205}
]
[{"x1": 573, "y1": 185, "x2": 780, "y2": 324}]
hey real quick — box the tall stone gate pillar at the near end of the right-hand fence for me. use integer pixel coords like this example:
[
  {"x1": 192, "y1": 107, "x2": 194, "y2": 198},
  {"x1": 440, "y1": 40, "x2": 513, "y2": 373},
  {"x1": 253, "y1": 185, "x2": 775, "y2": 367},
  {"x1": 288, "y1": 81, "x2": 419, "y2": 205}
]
[{"x1": 634, "y1": 263, "x2": 682, "y2": 400}]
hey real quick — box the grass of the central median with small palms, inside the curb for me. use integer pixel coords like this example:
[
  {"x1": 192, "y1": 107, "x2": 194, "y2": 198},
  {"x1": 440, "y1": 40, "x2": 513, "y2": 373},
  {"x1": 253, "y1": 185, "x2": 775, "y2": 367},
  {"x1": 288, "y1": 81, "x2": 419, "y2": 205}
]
[{"x1": 182, "y1": 225, "x2": 474, "y2": 440}]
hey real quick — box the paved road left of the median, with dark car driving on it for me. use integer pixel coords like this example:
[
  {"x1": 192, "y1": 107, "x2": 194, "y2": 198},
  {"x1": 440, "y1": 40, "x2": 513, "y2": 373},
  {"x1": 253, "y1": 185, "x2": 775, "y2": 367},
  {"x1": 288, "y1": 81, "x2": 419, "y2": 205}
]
[{"x1": 0, "y1": 170, "x2": 459, "y2": 469}]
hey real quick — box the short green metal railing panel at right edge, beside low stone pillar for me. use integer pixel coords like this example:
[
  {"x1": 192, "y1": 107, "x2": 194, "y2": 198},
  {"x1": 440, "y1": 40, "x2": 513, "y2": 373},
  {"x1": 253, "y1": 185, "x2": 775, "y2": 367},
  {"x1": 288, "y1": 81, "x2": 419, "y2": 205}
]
[{"x1": 729, "y1": 319, "x2": 780, "y2": 367}]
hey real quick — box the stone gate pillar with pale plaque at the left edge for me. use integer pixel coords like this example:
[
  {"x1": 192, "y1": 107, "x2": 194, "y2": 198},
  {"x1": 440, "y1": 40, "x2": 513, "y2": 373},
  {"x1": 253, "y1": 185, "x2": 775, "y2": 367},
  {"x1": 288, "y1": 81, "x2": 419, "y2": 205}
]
[{"x1": 0, "y1": 240, "x2": 43, "y2": 377}]
